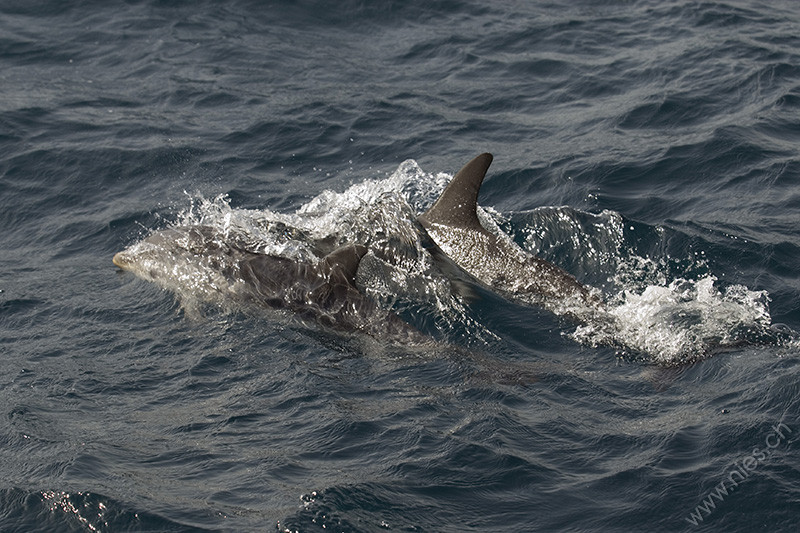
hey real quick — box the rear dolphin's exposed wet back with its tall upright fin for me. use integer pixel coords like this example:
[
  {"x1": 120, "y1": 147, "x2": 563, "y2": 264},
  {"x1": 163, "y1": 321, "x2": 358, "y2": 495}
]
[{"x1": 418, "y1": 153, "x2": 600, "y2": 319}]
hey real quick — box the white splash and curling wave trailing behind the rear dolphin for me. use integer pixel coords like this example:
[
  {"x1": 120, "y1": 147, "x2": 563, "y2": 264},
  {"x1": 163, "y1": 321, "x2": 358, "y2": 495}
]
[{"x1": 504, "y1": 207, "x2": 774, "y2": 365}]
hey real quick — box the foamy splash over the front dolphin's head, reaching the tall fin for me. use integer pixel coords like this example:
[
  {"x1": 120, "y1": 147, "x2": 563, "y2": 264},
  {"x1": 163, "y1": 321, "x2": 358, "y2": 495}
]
[{"x1": 115, "y1": 162, "x2": 492, "y2": 342}]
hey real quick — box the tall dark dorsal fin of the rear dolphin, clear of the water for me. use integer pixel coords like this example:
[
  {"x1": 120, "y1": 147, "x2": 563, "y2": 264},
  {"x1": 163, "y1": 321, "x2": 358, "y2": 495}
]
[{"x1": 419, "y1": 153, "x2": 492, "y2": 229}]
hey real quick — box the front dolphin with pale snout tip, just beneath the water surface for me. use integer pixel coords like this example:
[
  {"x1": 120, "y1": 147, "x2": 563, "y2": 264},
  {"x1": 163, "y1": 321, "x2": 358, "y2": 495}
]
[{"x1": 113, "y1": 226, "x2": 430, "y2": 344}]
